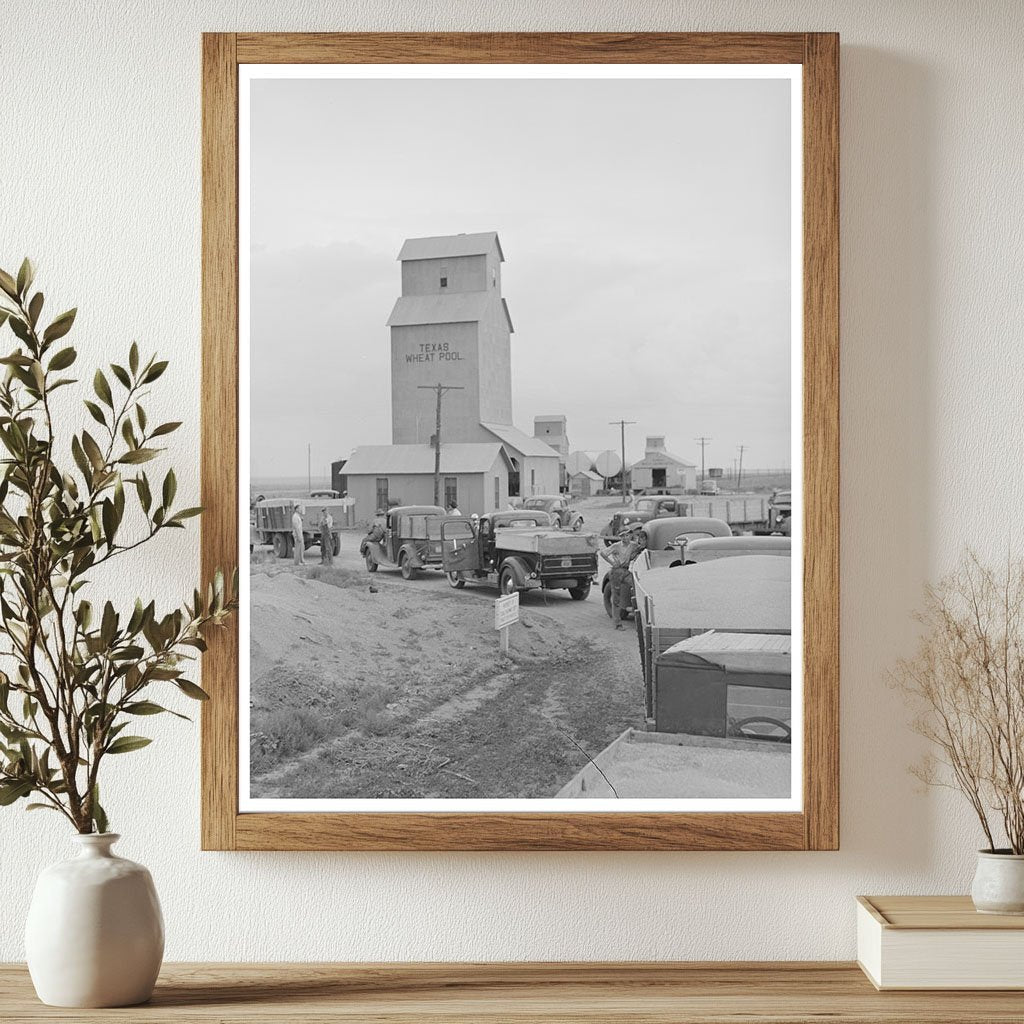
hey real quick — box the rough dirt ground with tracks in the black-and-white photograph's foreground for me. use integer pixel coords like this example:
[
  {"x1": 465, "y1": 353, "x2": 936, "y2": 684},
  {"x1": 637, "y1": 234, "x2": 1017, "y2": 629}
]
[{"x1": 251, "y1": 499, "x2": 643, "y2": 799}]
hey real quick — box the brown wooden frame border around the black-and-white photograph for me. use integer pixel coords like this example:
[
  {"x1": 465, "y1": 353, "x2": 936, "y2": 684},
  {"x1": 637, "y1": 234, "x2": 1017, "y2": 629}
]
[{"x1": 202, "y1": 33, "x2": 839, "y2": 851}]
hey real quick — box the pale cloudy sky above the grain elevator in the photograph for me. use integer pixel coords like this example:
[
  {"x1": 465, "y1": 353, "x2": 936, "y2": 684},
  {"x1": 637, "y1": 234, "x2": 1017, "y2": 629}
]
[{"x1": 251, "y1": 79, "x2": 791, "y2": 477}]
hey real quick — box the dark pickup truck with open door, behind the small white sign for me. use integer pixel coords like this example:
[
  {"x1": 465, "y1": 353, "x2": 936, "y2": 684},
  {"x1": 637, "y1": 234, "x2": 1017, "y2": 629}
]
[{"x1": 440, "y1": 509, "x2": 597, "y2": 601}]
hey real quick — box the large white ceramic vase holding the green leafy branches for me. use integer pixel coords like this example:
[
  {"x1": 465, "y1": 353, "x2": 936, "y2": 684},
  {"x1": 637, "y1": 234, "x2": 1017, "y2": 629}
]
[{"x1": 25, "y1": 833, "x2": 164, "y2": 1007}]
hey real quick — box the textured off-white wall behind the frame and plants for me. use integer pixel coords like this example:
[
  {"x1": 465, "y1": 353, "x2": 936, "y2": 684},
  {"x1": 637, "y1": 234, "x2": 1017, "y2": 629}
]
[{"x1": 0, "y1": 0, "x2": 1024, "y2": 959}]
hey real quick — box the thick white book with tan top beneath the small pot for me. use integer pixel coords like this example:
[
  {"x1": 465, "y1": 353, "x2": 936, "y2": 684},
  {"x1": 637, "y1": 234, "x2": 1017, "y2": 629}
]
[{"x1": 857, "y1": 896, "x2": 1024, "y2": 987}]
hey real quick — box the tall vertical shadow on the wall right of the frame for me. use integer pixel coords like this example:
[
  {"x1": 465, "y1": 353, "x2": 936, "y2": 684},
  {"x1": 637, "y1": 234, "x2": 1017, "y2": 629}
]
[{"x1": 840, "y1": 46, "x2": 937, "y2": 871}]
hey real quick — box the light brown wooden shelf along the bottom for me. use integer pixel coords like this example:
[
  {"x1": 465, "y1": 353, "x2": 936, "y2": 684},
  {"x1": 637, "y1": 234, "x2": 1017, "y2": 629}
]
[{"x1": 0, "y1": 963, "x2": 1024, "y2": 1024}]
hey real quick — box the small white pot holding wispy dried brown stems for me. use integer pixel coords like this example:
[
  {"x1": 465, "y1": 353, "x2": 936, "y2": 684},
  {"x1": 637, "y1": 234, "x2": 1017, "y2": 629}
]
[{"x1": 895, "y1": 553, "x2": 1024, "y2": 914}]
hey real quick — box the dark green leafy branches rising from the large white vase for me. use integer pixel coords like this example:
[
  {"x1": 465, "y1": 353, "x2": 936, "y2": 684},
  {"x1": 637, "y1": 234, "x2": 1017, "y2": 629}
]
[{"x1": 0, "y1": 259, "x2": 238, "y2": 834}]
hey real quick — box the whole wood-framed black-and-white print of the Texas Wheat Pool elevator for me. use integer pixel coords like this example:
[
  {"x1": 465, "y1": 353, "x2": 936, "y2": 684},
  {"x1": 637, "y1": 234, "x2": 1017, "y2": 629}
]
[{"x1": 202, "y1": 33, "x2": 839, "y2": 850}]
